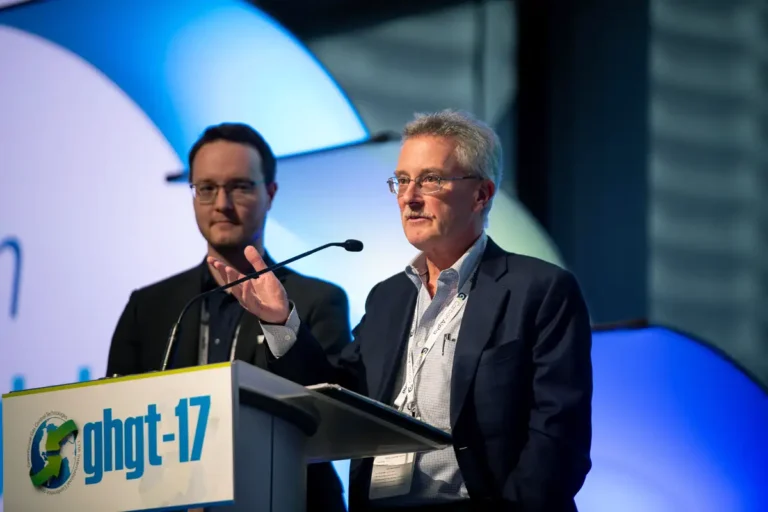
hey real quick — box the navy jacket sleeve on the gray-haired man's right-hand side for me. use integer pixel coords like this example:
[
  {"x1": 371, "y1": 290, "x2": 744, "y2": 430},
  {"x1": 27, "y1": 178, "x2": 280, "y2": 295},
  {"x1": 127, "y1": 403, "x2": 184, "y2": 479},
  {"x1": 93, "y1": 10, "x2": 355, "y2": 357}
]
[{"x1": 503, "y1": 271, "x2": 592, "y2": 511}]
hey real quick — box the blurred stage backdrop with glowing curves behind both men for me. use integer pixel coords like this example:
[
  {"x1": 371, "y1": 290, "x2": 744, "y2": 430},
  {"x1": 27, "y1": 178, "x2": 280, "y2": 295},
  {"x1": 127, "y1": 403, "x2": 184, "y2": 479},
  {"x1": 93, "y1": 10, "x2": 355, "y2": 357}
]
[{"x1": 0, "y1": 0, "x2": 768, "y2": 512}]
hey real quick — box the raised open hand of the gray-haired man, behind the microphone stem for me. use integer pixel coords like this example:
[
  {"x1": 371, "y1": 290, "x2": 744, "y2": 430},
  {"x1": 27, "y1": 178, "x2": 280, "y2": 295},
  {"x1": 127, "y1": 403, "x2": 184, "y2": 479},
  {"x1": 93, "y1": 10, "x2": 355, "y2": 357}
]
[{"x1": 208, "y1": 246, "x2": 291, "y2": 324}]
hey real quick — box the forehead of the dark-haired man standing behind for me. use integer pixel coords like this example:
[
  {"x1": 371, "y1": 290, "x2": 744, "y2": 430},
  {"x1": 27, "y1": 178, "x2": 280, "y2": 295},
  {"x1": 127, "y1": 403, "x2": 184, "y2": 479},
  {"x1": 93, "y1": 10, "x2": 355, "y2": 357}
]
[{"x1": 192, "y1": 140, "x2": 262, "y2": 180}]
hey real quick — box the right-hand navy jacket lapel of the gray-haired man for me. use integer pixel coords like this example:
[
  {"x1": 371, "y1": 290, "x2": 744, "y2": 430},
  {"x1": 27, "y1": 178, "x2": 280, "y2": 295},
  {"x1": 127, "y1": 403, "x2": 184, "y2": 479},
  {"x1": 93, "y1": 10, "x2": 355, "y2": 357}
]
[{"x1": 451, "y1": 242, "x2": 509, "y2": 427}]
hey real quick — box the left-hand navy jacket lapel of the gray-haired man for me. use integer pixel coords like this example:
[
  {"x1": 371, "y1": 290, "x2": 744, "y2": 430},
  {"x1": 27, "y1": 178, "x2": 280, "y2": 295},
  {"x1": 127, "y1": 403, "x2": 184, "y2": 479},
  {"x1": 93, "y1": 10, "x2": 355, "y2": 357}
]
[{"x1": 370, "y1": 278, "x2": 416, "y2": 404}]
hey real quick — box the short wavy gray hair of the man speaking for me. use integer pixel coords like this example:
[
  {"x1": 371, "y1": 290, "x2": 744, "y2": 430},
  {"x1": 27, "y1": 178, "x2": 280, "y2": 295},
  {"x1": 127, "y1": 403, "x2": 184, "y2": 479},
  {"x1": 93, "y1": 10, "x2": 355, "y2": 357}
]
[{"x1": 402, "y1": 109, "x2": 502, "y2": 217}]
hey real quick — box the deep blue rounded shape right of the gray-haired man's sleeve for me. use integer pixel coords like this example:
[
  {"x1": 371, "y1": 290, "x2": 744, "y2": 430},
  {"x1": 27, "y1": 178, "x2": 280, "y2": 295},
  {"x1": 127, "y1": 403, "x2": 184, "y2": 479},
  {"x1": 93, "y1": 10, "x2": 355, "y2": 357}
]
[{"x1": 577, "y1": 327, "x2": 768, "y2": 512}]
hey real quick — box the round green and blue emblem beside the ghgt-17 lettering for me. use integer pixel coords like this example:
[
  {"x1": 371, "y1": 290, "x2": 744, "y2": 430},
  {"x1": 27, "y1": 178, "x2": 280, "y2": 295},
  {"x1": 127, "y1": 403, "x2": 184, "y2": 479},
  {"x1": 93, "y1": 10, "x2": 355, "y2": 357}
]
[{"x1": 27, "y1": 411, "x2": 82, "y2": 494}]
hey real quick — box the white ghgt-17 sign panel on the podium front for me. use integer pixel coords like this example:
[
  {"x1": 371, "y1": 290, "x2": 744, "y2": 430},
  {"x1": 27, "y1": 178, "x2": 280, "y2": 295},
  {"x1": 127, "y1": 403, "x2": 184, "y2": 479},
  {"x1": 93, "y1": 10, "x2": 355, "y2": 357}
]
[{"x1": 3, "y1": 363, "x2": 234, "y2": 512}]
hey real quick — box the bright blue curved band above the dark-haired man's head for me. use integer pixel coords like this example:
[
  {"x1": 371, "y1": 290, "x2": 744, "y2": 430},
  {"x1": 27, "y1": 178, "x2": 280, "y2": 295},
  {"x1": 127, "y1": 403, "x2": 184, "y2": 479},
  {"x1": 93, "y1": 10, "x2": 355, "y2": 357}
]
[{"x1": 0, "y1": 0, "x2": 368, "y2": 162}]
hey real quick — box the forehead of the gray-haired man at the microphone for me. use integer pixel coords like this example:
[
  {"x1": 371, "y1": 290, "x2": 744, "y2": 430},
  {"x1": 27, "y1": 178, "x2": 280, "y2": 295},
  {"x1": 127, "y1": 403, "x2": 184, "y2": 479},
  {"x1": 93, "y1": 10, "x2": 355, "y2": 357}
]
[{"x1": 396, "y1": 135, "x2": 458, "y2": 175}]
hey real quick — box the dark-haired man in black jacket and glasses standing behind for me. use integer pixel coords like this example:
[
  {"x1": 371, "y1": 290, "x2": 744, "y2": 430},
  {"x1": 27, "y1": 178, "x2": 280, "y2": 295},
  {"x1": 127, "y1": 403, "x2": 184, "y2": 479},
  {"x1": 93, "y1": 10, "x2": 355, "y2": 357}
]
[{"x1": 107, "y1": 123, "x2": 350, "y2": 512}]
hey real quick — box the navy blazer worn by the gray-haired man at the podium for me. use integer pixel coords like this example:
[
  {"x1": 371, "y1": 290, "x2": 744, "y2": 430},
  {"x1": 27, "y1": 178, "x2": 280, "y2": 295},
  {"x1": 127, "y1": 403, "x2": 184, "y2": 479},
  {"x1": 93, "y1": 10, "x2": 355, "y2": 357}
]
[{"x1": 276, "y1": 239, "x2": 592, "y2": 512}]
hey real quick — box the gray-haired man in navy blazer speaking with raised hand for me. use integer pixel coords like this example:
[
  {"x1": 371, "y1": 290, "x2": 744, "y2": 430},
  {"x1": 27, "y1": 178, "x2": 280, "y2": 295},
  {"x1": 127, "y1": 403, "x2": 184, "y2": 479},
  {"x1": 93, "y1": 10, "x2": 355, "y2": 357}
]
[{"x1": 211, "y1": 111, "x2": 592, "y2": 512}]
